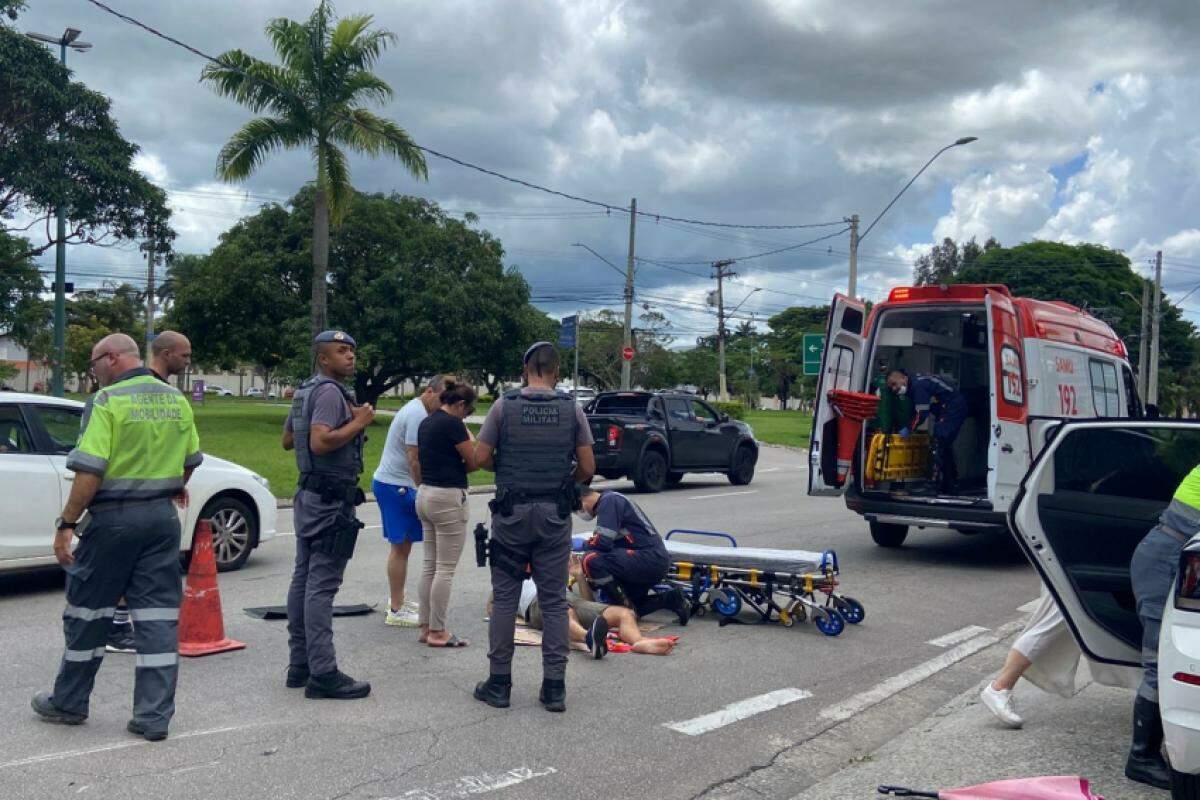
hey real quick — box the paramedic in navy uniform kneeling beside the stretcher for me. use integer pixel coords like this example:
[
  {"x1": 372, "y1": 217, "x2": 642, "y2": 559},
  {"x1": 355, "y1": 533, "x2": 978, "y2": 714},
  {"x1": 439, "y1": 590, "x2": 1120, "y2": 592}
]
[{"x1": 576, "y1": 488, "x2": 689, "y2": 625}]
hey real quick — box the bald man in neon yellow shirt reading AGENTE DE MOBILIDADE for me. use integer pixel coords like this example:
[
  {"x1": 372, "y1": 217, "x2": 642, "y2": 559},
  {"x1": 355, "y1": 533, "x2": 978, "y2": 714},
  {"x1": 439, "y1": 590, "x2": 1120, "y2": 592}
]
[{"x1": 32, "y1": 333, "x2": 203, "y2": 741}]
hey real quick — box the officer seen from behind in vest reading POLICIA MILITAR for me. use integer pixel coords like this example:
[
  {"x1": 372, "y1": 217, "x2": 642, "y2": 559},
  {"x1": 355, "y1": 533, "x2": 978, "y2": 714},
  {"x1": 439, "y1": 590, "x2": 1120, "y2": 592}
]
[{"x1": 475, "y1": 342, "x2": 595, "y2": 711}]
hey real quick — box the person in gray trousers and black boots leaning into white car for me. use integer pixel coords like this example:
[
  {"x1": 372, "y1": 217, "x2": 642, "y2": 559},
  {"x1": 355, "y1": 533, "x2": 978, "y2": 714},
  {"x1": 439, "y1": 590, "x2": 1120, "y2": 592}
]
[{"x1": 1126, "y1": 467, "x2": 1200, "y2": 789}]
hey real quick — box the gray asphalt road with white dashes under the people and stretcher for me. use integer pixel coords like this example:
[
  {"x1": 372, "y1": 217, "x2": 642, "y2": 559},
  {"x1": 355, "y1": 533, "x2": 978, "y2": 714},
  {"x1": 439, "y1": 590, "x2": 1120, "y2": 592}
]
[{"x1": 0, "y1": 449, "x2": 1037, "y2": 800}]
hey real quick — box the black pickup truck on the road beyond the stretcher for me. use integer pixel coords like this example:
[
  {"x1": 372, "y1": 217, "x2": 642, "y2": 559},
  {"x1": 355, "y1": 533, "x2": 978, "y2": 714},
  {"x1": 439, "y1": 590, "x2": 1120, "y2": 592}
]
[{"x1": 583, "y1": 392, "x2": 758, "y2": 492}]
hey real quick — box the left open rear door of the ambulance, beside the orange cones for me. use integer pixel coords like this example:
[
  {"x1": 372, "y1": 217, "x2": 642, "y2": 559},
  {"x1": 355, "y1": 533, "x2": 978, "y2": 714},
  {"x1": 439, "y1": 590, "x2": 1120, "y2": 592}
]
[{"x1": 809, "y1": 294, "x2": 866, "y2": 495}]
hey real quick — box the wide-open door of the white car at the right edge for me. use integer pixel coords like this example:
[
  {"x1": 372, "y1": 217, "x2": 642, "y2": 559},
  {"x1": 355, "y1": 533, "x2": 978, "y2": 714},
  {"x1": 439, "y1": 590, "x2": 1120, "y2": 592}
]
[{"x1": 1009, "y1": 420, "x2": 1200, "y2": 666}]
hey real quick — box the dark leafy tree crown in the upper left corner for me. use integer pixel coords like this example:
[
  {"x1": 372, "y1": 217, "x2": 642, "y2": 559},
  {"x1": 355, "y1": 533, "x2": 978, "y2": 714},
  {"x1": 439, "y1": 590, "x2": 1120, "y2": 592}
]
[{"x1": 0, "y1": 25, "x2": 174, "y2": 257}]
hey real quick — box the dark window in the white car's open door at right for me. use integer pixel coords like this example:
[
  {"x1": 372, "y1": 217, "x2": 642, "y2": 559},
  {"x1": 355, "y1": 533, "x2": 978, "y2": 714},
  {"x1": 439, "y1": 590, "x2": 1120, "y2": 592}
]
[{"x1": 1054, "y1": 427, "x2": 1200, "y2": 504}]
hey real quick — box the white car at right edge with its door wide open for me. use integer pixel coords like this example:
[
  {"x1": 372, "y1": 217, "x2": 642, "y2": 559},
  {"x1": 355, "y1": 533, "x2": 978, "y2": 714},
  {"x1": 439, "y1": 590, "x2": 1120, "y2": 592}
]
[{"x1": 1009, "y1": 420, "x2": 1200, "y2": 800}]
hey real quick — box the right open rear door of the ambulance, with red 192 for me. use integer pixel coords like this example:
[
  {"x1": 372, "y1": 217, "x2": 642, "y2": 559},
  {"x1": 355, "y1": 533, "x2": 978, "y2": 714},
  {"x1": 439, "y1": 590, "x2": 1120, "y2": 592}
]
[{"x1": 985, "y1": 291, "x2": 1030, "y2": 511}]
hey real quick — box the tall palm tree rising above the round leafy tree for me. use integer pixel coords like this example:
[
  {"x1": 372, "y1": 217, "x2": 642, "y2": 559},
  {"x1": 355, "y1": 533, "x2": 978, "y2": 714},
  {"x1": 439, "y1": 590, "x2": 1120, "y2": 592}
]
[{"x1": 200, "y1": 0, "x2": 427, "y2": 335}]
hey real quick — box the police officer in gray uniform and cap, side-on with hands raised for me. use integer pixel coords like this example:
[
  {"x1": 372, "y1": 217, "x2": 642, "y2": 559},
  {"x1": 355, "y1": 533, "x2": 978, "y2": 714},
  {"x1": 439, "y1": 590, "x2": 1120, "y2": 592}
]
[{"x1": 283, "y1": 331, "x2": 374, "y2": 699}]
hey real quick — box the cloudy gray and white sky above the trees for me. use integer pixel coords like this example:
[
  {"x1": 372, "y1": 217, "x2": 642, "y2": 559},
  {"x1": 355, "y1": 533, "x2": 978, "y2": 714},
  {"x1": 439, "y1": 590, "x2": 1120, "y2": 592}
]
[{"x1": 17, "y1": 0, "x2": 1200, "y2": 339}]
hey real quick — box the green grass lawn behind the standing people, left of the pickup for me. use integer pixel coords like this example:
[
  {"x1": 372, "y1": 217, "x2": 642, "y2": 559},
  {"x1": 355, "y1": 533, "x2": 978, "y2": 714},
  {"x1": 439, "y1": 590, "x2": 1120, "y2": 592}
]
[{"x1": 194, "y1": 397, "x2": 493, "y2": 498}]
